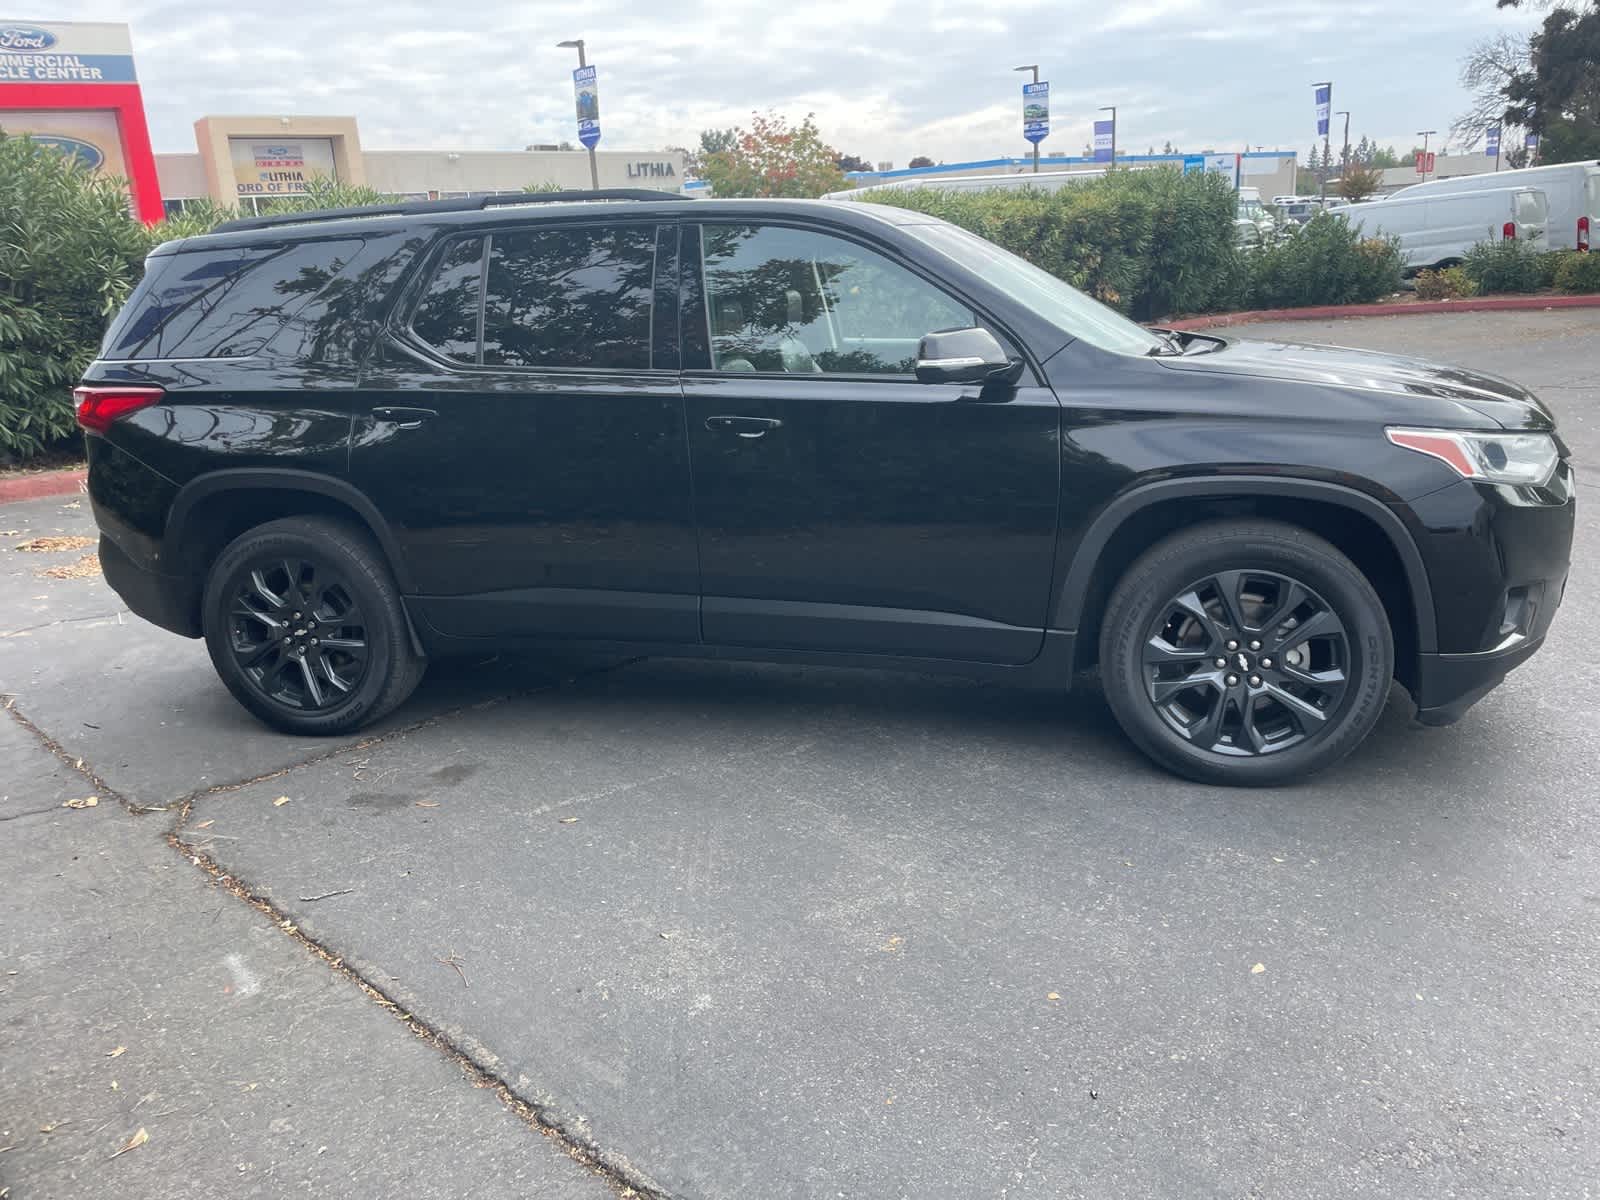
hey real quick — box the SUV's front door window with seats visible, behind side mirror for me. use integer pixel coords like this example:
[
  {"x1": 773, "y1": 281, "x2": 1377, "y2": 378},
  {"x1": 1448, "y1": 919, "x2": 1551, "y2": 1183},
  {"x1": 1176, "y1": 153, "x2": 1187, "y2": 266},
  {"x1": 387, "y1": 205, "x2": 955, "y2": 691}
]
[{"x1": 702, "y1": 226, "x2": 978, "y2": 374}]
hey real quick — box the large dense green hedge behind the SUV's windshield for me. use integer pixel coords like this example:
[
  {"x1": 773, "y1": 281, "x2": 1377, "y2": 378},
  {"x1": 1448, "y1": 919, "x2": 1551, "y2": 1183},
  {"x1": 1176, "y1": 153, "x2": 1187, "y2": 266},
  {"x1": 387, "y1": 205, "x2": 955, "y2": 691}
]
[{"x1": 861, "y1": 170, "x2": 1243, "y2": 320}]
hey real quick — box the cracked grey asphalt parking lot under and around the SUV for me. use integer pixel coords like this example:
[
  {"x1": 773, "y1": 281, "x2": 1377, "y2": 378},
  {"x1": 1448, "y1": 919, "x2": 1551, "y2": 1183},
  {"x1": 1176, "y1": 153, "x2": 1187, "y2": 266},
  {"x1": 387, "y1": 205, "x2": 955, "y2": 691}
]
[{"x1": 0, "y1": 310, "x2": 1600, "y2": 1200}]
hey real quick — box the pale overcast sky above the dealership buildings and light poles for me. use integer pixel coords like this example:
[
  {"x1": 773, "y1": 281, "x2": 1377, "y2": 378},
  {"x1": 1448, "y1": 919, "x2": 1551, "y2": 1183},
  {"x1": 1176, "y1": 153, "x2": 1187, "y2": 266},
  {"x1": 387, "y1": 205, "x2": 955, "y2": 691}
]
[{"x1": 43, "y1": 0, "x2": 1538, "y2": 166}]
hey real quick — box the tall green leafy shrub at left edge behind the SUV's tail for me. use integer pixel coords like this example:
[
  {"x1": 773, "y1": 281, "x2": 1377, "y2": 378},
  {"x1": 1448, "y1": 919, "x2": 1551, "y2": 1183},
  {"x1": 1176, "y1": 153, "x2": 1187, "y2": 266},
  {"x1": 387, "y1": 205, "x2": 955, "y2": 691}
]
[{"x1": 0, "y1": 134, "x2": 149, "y2": 458}]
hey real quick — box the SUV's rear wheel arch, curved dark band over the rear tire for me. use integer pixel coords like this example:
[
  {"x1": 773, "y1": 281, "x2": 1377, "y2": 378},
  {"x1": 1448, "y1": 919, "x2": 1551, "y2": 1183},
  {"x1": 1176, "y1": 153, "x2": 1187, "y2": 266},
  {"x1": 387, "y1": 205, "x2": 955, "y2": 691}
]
[{"x1": 163, "y1": 467, "x2": 411, "y2": 592}]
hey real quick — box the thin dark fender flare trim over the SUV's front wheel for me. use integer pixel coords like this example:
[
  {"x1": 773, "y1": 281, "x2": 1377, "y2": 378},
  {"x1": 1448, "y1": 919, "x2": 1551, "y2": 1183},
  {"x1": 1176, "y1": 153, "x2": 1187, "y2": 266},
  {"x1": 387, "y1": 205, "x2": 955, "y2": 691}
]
[{"x1": 1050, "y1": 475, "x2": 1438, "y2": 654}]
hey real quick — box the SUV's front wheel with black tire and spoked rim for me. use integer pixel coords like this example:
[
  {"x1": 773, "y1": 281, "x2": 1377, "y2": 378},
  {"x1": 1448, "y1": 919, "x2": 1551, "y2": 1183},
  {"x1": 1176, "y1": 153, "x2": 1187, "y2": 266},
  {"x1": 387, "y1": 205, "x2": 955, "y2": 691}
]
[{"x1": 1099, "y1": 520, "x2": 1394, "y2": 786}]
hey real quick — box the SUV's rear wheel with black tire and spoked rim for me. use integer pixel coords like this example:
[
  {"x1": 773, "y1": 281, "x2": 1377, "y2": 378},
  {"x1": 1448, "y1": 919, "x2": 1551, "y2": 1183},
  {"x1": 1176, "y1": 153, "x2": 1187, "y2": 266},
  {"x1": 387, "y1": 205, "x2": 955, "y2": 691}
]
[{"x1": 202, "y1": 517, "x2": 427, "y2": 736}]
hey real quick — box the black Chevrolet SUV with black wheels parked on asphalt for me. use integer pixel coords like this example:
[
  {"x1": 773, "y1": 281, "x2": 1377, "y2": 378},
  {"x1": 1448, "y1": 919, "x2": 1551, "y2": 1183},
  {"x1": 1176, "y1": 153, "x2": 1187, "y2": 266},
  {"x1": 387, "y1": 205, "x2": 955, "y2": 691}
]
[{"x1": 78, "y1": 192, "x2": 1574, "y2": 784}]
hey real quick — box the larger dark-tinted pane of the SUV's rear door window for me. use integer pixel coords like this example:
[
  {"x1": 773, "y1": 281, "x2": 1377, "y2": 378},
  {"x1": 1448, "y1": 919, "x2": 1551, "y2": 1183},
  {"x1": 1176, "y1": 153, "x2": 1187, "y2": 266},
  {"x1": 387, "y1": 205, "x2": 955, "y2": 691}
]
[{"x1": 483, "y1": 226, "x2": 656, "y2": 370}]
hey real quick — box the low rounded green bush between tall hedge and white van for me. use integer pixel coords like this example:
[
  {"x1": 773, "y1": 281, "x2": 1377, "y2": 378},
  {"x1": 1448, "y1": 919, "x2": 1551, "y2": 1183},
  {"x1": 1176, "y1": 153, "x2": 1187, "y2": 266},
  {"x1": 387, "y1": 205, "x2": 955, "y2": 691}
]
[{"x1": 1250, "y1": 213, "x2": 1402, "y2": 309}]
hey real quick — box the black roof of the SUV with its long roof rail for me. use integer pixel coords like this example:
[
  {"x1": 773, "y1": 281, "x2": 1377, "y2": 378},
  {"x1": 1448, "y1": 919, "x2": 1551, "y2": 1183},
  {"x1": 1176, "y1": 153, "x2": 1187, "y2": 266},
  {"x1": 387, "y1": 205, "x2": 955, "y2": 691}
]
[{"x1": 155, "y1": 187, "x2": 934, "y2": 254}]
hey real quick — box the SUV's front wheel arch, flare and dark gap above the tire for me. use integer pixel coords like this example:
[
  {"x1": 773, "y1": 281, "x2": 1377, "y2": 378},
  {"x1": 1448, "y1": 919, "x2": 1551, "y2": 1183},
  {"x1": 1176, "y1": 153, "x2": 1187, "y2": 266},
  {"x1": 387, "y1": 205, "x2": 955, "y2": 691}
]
[{"x1": 1051, "y1": 475, "x2": 1438, "y2": 688}]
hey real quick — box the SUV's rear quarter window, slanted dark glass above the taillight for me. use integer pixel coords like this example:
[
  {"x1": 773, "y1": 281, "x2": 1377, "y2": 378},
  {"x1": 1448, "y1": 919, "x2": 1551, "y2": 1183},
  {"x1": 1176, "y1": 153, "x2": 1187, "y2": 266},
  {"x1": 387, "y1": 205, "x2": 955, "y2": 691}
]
[{"x1": 101, "y1": 238, "x2": 363, "y2": 358}]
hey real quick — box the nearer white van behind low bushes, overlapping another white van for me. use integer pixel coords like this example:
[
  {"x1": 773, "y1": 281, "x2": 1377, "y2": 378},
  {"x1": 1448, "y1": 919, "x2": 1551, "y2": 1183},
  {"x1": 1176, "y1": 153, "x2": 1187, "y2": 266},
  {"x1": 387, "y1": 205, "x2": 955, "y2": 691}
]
[{"x1": 1331, "y1": 187, "x2": 1550, "y2": 272}]
